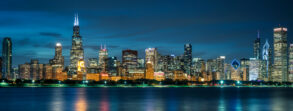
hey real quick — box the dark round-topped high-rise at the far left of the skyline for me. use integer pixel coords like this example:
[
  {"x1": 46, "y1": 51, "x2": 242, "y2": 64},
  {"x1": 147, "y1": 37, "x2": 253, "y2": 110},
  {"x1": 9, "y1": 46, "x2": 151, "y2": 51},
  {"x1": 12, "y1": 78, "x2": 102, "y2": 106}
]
[{"x1": 2, "y1": 37, "x2": 12, "y2": 79}]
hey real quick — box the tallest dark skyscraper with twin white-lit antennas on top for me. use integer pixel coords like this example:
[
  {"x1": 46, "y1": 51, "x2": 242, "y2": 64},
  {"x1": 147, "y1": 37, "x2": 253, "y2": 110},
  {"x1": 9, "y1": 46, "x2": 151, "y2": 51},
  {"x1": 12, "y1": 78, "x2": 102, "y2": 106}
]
[{"x1": 69, "y1": 14, "x2": 84, "y2": 75}]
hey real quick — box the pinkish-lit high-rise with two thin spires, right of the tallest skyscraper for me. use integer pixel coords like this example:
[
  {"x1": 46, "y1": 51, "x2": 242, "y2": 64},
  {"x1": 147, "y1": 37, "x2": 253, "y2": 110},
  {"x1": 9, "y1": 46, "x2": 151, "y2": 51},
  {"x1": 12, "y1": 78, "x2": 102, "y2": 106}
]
[{"x1": 98, "y1": 45, "x2": 108, "y2": 71}]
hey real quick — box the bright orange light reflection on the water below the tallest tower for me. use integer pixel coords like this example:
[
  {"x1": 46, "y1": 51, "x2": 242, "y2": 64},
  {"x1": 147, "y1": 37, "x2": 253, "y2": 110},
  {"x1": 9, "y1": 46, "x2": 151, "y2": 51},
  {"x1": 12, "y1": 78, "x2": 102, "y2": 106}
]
[{"x1": 75, "y1": 88, "x2": 87, "y2": 111}]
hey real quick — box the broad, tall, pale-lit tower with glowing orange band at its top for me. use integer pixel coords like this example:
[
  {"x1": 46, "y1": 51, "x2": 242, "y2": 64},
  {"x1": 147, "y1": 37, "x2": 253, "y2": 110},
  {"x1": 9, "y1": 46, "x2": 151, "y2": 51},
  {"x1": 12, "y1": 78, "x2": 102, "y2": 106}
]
[{"x1": 272, "y1": 27, "x2": 288, "y2": 82}]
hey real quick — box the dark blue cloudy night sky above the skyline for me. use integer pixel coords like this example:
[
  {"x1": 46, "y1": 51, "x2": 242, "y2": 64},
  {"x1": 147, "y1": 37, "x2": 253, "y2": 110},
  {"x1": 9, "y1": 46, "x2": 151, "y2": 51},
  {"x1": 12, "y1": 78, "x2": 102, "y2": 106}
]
[{"x1": 0, "y1": 0, "x2": 293, "y2": 66}]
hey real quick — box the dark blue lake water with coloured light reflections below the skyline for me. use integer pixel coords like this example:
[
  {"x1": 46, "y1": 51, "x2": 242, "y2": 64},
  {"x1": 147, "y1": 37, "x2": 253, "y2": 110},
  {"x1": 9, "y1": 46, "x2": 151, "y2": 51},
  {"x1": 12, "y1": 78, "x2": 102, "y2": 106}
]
[{"x1": 0, "y1": 87, "x2": 293, "y2": 111}]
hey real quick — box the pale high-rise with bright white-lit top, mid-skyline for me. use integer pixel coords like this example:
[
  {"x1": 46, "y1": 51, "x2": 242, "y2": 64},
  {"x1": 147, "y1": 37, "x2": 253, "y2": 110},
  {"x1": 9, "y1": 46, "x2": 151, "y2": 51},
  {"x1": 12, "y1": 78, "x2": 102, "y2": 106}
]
[{"x1": 145, "y1": 48, "x2": 159, "y2": 71}]
